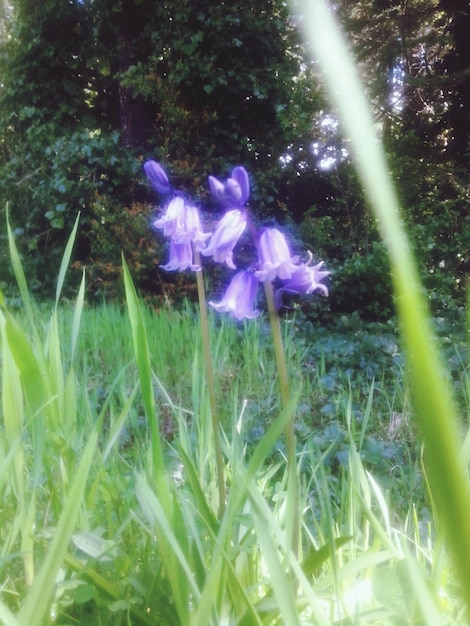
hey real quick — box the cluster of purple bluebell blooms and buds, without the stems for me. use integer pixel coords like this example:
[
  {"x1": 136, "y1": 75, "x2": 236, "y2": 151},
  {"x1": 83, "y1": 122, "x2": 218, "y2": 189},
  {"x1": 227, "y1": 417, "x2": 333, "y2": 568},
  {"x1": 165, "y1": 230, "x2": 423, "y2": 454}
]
[{"x1": 144, "y1": 161, "x2": 329, "y2": 319}]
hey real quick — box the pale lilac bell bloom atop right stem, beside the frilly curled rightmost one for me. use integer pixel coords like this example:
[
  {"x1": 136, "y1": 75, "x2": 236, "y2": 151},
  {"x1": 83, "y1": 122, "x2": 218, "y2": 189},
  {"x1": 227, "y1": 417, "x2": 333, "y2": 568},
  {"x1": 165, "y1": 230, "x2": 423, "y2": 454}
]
[{"x1": 255, "y1": 228, "x2": 299, "y2": 282}]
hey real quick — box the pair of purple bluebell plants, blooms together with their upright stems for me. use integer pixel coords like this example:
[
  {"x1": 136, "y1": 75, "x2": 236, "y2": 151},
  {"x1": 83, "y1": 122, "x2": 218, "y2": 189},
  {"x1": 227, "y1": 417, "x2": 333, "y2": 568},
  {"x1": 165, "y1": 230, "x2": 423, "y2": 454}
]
[{"x1": 144, "y1": 160, "x2": 329, "y2": 532}]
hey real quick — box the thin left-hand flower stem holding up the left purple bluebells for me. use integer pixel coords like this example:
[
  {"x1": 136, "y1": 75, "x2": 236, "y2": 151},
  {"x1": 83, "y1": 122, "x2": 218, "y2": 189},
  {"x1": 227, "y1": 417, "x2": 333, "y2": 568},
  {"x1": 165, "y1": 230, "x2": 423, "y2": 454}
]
[{"x1": 193, "y1": 246, "x2": 225, "y2": 518}]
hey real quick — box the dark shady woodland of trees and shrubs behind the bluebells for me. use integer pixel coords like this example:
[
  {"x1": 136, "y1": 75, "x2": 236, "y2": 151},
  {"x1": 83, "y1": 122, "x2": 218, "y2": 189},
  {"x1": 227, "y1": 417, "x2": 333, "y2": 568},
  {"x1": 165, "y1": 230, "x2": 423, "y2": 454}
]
[{"x1": 0, "y1": 0, "x2": 470, "y2": 321}]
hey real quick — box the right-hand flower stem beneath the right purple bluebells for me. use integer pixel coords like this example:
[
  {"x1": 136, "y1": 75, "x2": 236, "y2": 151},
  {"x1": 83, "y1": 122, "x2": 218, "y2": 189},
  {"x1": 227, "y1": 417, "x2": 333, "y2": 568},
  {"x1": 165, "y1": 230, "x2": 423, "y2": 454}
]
[{"x1": 264, "y1": 281, "x2": 299, "y2": 557}]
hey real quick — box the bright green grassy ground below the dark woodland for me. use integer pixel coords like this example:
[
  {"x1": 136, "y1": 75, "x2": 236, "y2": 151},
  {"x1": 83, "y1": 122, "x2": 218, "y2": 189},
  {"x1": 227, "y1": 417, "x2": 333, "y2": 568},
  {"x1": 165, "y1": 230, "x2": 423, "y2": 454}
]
[{"x1": 0, "y1": 286, "x2": 466, "y2": 626}]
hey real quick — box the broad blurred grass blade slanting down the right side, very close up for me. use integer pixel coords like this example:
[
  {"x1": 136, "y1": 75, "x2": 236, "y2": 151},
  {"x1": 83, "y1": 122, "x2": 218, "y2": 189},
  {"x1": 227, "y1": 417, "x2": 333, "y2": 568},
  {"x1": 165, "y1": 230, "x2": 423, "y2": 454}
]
[{"x1": 298, "y1": 0, "x2": 470, "y2": 607}]
